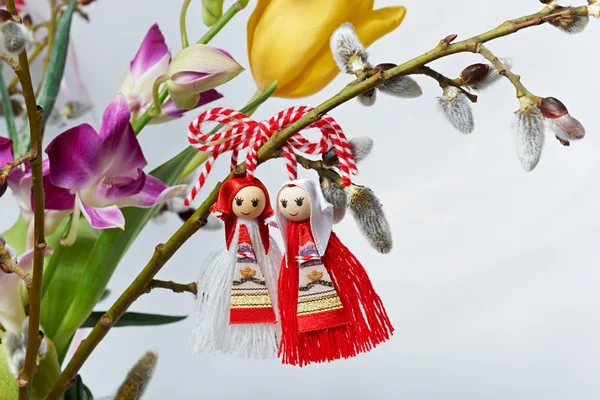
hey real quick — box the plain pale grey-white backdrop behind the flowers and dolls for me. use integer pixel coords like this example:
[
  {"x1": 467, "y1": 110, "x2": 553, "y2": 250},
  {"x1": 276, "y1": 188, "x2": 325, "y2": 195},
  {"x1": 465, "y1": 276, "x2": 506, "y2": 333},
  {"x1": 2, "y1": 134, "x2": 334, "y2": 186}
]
[{"x1": 0, "y1": 0, "x2": 600, "y2": 400}]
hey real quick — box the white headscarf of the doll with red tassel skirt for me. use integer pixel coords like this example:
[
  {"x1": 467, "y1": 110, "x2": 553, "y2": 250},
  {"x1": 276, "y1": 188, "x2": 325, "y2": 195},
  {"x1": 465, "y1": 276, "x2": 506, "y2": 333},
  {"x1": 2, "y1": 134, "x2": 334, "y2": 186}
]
[{"x1": 274, "y1": 179, "x2": 333, "y2": 257}]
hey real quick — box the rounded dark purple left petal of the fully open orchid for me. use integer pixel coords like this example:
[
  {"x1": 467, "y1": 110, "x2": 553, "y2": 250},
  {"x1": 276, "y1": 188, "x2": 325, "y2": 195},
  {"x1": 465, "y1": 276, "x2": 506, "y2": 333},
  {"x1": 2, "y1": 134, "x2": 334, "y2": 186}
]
[{"x1": 46, "y1": 124, "x2": 102, "y2": 190}]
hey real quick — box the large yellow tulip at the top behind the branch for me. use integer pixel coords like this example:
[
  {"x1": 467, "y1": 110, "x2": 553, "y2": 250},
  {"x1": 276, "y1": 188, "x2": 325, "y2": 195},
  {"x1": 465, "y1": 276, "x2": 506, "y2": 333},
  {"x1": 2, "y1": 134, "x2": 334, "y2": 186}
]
[{"x1": 248, "y1": 0, "x2": 406, "y2": 98}]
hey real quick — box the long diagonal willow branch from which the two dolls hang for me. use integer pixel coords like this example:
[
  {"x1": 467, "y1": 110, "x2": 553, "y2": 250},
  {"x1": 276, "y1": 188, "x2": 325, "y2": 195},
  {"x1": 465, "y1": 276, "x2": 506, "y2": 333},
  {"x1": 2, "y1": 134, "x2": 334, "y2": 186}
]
[{"x1": 46, "y1": 6, "x2": 587, "y2": 400}]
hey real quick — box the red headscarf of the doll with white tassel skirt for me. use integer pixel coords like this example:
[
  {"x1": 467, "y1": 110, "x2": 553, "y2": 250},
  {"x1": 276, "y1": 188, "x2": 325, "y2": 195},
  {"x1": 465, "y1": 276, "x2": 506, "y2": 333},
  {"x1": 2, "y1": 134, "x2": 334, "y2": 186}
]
[{"x1": 210, "y1": 177, "x2": 274, "y2": 253}]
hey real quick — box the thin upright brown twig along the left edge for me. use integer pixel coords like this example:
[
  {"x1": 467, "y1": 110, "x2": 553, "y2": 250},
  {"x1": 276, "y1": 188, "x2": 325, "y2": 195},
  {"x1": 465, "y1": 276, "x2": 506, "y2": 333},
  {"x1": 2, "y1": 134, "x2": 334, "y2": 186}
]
[{"x1": 6, "y1": 0, "x2": 46, "y2": 400}]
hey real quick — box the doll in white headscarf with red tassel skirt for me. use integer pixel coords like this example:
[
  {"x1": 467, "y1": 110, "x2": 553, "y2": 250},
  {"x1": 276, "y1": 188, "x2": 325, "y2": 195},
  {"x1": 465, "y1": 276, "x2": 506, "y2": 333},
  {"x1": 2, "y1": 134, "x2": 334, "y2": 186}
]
[{"x1": 276, "y1": 179, "x2": 393, "y2": 366}]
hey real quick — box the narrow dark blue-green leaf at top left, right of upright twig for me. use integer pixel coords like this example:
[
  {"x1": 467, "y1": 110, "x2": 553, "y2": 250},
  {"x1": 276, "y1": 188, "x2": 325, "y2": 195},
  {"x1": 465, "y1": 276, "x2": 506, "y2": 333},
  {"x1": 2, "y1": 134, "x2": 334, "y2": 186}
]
[{"x1": 37, "y1": 0, "x2": 77, "y2": 129}]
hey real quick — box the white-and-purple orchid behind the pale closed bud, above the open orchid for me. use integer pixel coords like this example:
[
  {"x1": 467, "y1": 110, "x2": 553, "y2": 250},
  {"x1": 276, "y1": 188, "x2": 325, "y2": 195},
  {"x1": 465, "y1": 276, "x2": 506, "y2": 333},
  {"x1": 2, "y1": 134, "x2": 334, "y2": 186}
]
[{"x1": 118, "y1": 24, "x2": 223, "y2": 123}]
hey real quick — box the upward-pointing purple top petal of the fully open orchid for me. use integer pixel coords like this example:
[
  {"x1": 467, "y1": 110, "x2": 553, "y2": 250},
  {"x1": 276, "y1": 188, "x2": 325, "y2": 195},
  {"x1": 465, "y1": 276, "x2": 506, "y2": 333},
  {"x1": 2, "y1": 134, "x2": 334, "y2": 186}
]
[{"x1": 100, "y1": 95, "x2": 147, "y2": 176}]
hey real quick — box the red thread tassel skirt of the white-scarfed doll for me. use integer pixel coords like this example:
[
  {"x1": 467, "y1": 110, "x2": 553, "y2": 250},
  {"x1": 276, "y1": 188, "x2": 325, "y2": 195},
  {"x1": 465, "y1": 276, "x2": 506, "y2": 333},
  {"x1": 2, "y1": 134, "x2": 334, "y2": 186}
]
[{"x1": 279, "y1": 224, "x2": 394, "y2": 366}]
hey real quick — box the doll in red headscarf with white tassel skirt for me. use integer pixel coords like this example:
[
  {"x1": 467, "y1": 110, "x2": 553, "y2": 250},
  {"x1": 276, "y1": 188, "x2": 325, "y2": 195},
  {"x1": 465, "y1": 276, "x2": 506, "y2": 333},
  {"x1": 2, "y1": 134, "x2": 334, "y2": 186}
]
[{"x1": 190, "y1": 177, "x2": 282, "y2": 358}]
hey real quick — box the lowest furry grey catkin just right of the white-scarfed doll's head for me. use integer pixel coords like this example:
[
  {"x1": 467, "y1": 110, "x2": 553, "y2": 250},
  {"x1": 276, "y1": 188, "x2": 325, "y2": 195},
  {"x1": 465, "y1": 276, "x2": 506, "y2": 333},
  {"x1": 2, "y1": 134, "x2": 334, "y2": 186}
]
[{"x1": 346, "y1": 185, "x2": 393, "y2": 254}]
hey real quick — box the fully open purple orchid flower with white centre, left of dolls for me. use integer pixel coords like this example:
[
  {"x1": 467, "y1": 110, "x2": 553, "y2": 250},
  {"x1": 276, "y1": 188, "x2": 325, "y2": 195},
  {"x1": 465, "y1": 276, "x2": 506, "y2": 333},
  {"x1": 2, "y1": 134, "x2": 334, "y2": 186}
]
[{"x1": 46, "y1": 96, "x2": 185, "y2": 239}]
